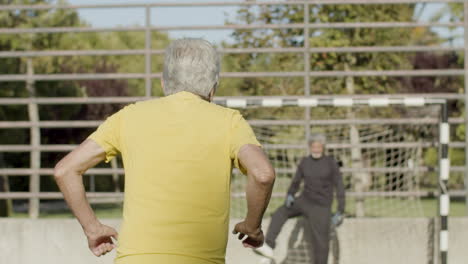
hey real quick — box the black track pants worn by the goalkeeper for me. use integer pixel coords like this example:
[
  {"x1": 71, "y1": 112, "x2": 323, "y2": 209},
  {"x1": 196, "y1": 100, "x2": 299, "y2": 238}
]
[{"x1": 265, "y1": 197, "x2": 331, "y2": 264}]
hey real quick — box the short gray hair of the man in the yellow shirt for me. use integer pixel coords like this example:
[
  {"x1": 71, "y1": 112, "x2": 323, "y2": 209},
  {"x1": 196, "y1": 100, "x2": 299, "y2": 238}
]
[{"x1": 163, "y1": 38, "x2": 220, "y2": 97}]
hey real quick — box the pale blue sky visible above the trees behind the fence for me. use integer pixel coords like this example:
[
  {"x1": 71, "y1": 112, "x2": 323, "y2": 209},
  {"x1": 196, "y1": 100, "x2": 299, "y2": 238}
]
[{"x1": 68, "y1": 0, "x2": 463, "y2": 46}]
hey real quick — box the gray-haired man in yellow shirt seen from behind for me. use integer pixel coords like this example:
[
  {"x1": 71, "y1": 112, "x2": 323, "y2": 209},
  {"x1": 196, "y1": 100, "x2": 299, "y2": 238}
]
[{"x1": 54, "y1": 39, "x2": 275, "y2": 264}]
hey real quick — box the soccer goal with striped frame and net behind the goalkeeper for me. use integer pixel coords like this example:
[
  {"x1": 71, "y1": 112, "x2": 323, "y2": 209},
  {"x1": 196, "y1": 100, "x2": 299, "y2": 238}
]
[{"x1": 221, "y1": 96, "x2": 450, "y2": 264}]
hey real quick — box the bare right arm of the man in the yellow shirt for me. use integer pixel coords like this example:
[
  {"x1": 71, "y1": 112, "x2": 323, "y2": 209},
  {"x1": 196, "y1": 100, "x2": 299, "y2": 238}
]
[{"x1": 233, "y1": 144, "x2": 276, "y2": 248}]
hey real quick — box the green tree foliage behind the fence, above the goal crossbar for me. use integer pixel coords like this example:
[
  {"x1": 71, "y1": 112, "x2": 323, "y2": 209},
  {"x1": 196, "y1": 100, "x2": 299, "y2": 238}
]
[{"x1": 221, "y1": 5, "x2": 432, "y2": 98}]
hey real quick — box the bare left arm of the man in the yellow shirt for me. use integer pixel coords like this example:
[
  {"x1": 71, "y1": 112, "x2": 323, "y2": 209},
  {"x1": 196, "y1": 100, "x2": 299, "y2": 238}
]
[{"x1": 54, "y1": 139, "x2": 117, "y2": 256}]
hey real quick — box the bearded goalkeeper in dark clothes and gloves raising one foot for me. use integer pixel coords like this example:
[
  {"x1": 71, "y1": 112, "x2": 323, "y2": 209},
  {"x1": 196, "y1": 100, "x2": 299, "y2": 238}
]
[{"x1": 254, "y1": 134, "x2": 345, "y2": 264}]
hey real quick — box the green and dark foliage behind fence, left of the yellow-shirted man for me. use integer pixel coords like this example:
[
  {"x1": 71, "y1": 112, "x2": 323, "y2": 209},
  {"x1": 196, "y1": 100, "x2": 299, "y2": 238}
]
[{"x1": 0, "y1": 0, "x2": 169, "y2": 194}]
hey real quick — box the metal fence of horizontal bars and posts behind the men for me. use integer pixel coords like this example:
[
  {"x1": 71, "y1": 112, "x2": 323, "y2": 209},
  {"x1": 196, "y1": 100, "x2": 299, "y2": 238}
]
[{"x1": 0, "y1": 0, "x2": 468, "y2": 227}]
